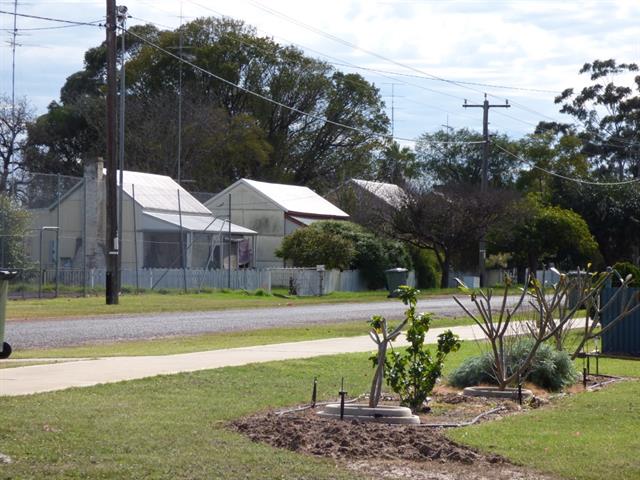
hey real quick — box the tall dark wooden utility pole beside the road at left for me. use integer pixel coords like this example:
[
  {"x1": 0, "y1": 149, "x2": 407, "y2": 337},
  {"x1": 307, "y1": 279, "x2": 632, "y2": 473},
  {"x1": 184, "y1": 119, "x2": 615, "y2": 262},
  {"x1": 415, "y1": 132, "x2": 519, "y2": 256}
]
[{"x1": 105, "y1": 0, "x2": 120, "y2": 305}]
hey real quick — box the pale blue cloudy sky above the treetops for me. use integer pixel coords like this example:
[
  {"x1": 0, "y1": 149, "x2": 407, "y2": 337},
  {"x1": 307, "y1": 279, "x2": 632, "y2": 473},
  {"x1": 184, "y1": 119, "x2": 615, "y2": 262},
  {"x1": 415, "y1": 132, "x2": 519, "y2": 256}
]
[{"x1": 0, "y1": 0, "x2": 640, "y2": 145}]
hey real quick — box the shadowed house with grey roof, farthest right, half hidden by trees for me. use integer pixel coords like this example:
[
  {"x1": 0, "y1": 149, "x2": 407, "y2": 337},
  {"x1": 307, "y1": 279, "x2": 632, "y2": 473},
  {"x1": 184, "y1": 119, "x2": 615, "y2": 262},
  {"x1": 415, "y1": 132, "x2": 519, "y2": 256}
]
[{"x1": 325, "y1": 178, "x2": 406, "y2": 227}]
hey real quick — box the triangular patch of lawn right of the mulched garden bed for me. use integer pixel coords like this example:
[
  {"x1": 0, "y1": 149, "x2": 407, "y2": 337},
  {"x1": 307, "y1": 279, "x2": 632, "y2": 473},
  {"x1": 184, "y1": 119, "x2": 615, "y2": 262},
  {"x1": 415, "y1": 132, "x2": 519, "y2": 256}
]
[{"x1": 448, "y1": 360, "x2": 640, "y2": 480}]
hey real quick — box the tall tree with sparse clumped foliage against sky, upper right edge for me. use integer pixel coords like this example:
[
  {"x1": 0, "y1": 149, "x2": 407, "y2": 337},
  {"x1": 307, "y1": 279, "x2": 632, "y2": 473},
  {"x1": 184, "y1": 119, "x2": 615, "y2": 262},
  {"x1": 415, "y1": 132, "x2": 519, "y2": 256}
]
[{"x1": 555, "y1": 59, "x2": 640, "y2": 179}]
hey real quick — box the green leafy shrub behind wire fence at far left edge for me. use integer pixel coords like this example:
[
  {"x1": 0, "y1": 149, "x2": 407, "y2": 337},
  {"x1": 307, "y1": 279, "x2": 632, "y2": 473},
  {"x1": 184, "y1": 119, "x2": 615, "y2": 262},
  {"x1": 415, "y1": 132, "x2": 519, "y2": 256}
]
[{"x1": 0, "y1": 193, "x2": 30, "y2": 268}]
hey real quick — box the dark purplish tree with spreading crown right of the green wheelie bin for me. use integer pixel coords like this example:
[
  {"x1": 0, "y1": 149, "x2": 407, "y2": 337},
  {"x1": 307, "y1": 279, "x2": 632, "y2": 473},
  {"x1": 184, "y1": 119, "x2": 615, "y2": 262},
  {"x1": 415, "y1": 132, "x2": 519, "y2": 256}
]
[{"x1": 392, "y1": 185, "x2": 514, "y2": 288}]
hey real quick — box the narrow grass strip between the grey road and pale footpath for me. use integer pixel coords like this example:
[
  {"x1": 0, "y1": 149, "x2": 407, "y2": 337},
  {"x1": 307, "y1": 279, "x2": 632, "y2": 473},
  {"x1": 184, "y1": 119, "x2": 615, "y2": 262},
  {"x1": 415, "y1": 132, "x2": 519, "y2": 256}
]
[{"x1": 11, "y1": 318, "x2": 471, "y2": 359}]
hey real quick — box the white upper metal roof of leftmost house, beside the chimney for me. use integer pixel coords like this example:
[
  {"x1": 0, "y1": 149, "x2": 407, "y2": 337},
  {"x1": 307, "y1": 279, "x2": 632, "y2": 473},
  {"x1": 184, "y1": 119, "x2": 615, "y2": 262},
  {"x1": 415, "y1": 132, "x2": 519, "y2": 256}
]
[{"x1": 117, "y1": 170, "x2": 211, "y2": 214}]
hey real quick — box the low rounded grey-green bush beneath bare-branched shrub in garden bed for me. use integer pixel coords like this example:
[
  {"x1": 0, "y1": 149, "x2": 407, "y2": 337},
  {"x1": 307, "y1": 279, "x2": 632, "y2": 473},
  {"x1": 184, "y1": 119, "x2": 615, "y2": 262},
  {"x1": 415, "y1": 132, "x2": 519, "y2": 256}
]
[{"x1": 449, "y1": 339, "x2": 577, "y2": 392}]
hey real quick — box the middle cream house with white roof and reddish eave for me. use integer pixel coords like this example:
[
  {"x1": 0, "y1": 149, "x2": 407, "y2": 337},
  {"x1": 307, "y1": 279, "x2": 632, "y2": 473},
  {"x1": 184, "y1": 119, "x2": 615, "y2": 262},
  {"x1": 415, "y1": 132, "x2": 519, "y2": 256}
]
[{"x1": 205, "y1": 178, "x2": 349, "y2": 268}]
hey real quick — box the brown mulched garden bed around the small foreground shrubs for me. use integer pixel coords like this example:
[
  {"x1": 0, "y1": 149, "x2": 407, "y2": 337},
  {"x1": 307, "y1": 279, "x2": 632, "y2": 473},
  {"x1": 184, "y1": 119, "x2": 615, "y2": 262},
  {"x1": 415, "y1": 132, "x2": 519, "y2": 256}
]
[{"x1": 231, "y1": 376, "x2": 624, "y2": 480}]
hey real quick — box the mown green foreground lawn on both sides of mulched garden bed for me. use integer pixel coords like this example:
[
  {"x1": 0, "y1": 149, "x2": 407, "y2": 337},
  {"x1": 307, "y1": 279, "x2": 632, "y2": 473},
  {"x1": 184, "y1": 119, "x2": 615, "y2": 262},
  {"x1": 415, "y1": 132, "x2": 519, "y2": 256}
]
[{"x1": 0, "y1": 342, "x2": 640, "y2": 479}]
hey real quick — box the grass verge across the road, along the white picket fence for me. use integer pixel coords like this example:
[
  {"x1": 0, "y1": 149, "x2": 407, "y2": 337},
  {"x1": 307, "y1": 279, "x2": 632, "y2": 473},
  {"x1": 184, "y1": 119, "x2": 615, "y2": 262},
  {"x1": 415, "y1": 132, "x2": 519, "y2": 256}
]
[{"x1": 7, "y1": 289, "x2": 455, "y2": 320}]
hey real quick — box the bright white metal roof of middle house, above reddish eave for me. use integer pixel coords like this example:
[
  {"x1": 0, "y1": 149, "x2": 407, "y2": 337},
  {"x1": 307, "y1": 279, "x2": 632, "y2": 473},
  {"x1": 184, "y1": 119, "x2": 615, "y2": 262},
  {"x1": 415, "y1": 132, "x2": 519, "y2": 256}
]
[{"x1": 239, "y1": 178, "x2": 349, "y2": 218}]
